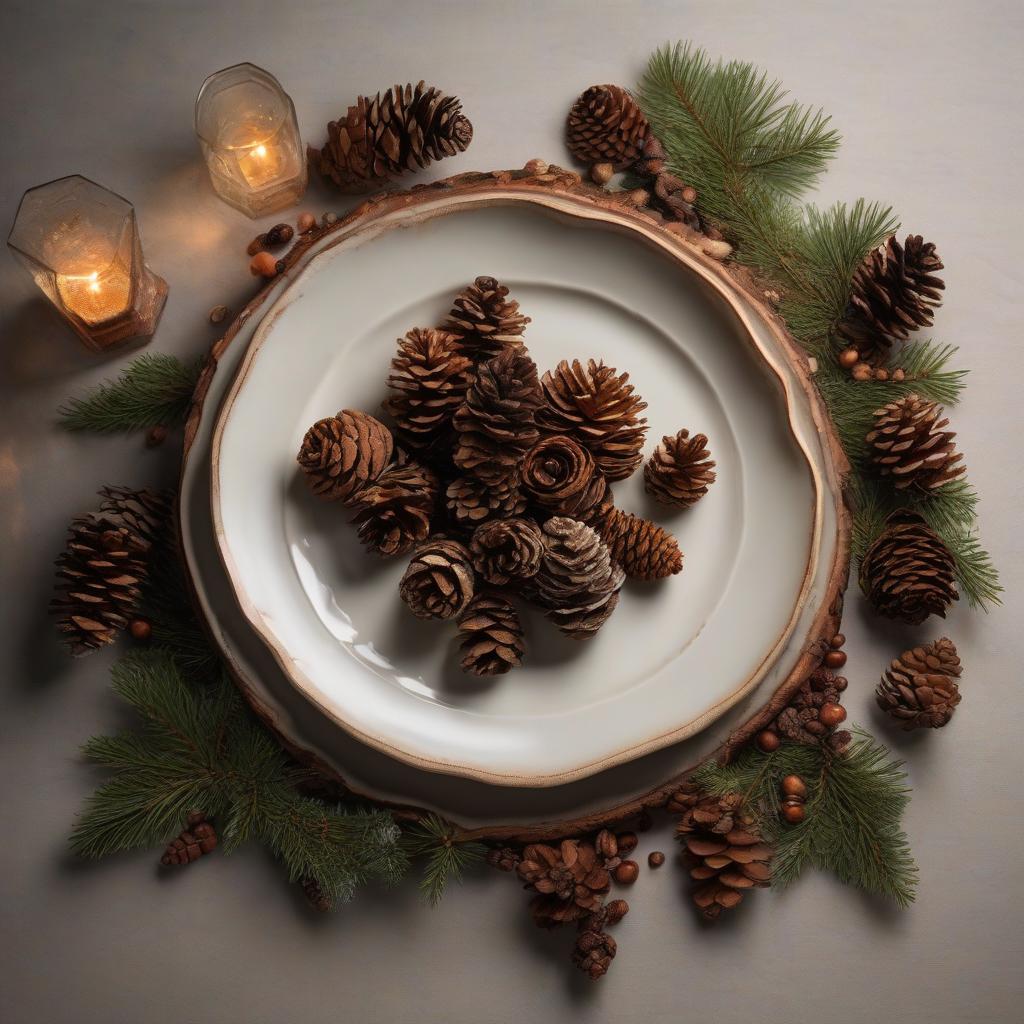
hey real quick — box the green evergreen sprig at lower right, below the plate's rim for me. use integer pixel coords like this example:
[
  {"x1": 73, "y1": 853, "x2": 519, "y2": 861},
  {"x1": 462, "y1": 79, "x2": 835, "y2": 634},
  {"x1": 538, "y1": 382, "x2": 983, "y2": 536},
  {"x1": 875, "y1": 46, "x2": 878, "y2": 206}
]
[{"x1": 694, "y1": 730, "x2": 918, "y2": 907}]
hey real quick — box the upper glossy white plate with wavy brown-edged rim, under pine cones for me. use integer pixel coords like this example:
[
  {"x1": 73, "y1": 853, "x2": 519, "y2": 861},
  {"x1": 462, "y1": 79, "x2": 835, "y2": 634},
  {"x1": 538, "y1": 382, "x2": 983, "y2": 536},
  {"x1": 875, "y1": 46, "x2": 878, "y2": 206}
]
[{"x1": 212, "y1": 190, "x2": 822, "y2": 785}]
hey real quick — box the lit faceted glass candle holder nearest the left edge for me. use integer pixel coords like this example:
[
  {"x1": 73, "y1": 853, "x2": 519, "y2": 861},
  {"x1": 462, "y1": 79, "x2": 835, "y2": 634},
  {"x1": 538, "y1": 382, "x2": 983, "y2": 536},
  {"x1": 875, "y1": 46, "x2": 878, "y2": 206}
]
[{"x1": 7, "y1": 174, "x2": 167, "y2": 351}]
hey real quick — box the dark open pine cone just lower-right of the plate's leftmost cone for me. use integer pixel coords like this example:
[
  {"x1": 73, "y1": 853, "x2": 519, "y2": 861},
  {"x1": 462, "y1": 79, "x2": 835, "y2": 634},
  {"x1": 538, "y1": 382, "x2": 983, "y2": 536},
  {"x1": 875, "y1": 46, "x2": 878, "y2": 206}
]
[{"x1": 352, "y1": 456, "x2": 440, "y2": 556}]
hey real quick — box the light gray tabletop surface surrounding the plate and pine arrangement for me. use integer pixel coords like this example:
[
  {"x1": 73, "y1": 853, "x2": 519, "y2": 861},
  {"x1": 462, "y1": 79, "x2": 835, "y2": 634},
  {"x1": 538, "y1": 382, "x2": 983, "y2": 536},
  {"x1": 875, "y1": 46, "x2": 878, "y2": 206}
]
[{"x1": 0, "y1": 0, "x2": 1024, "y2": 1024}]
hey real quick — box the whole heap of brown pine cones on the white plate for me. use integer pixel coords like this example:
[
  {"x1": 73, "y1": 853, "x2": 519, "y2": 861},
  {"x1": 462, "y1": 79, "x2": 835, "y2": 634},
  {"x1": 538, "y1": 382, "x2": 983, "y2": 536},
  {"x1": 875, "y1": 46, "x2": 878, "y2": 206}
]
[{"x1": 298, "y1": 278, "x2": 715, "y2": 676}]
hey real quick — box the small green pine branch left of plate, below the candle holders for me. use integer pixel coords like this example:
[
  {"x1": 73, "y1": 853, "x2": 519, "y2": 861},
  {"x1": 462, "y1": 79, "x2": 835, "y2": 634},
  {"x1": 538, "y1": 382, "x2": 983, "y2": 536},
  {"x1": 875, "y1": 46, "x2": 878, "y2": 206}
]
[{"x1": 57, "y1": 352, "x2": 203, "y2": 433}]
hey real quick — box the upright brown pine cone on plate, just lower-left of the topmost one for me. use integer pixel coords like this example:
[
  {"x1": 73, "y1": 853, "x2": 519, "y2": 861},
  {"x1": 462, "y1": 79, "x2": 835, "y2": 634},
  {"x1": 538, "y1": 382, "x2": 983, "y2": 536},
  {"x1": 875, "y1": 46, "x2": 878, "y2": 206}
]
[{"x1": 384, "y1": 328, "x2": 472, "y2": 449}]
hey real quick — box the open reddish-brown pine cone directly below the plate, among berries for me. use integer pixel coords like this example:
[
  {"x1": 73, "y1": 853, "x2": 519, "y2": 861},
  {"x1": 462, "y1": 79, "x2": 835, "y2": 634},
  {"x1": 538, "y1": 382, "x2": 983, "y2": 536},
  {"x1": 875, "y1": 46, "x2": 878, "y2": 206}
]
[{"x1": 516, "y1": 839, "x2": 611, "y2": 928}]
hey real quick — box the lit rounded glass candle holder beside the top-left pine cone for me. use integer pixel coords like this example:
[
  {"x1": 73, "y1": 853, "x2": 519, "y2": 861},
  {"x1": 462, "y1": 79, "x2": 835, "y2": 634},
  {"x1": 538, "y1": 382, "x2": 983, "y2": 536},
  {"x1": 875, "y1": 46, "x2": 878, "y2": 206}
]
[{"x1": 196, "y1": 63, "x2": 306, "y2": 217}]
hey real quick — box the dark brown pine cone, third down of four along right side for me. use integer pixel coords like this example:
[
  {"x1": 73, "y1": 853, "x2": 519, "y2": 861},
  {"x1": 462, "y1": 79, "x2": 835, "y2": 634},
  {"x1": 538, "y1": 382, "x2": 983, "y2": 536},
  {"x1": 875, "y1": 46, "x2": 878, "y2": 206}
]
[{"x1": 860, "y1": 511, "x2": 959, "y2": 626}]
